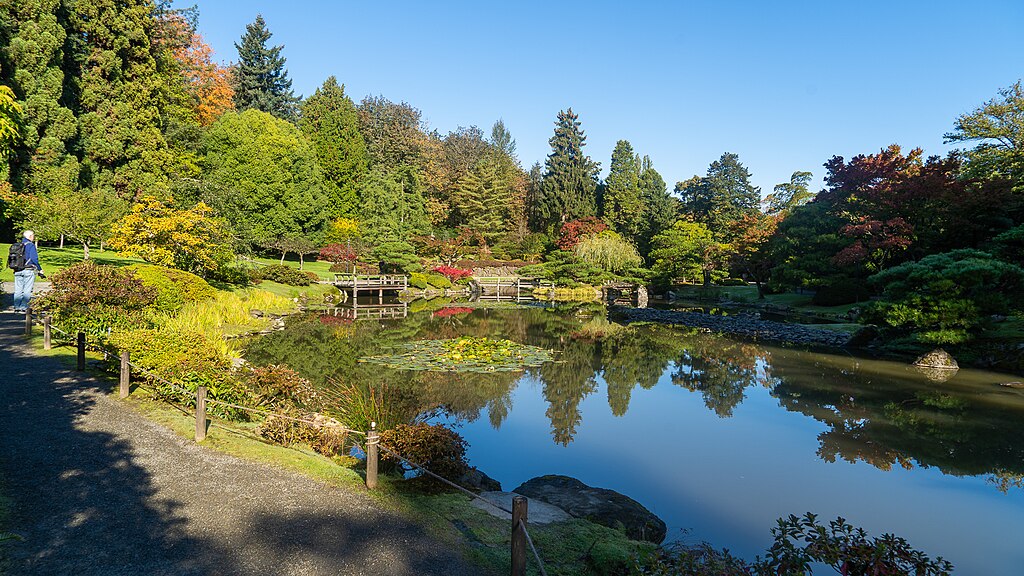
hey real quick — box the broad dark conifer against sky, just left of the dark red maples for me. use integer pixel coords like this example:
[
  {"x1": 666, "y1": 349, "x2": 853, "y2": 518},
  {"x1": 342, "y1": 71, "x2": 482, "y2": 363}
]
[{"x1": 676, "y1": 152, "x2": 761, "y2": 241}]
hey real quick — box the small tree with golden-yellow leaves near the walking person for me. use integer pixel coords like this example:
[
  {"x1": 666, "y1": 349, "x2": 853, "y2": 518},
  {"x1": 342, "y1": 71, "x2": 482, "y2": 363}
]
[{"x1": 110, "y1": 197, "x2": 234, "y2": 276}]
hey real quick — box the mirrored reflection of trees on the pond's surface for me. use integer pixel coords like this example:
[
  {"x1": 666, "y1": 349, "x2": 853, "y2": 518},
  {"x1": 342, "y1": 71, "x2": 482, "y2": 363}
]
[{"x1": 247, "y1": 302, "x2": 1024, "y2": 490}]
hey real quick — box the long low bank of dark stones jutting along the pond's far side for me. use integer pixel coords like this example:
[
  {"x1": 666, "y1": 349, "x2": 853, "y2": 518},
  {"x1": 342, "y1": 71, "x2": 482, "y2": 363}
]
[{"x1": 614, "y1": 307, "x2": 850, "y2": 347}]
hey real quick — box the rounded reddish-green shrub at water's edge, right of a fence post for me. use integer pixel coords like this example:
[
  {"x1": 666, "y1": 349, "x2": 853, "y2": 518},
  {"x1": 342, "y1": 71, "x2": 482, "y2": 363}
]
[{"x1": 381, "y1": 423, "x2": 469, "y2": 480}]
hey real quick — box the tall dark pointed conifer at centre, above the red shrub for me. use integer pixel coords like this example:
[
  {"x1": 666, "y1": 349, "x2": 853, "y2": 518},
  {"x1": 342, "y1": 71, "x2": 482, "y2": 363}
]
[{"x1": 535, "y1": 108, "x2": 600, "y2": 228}]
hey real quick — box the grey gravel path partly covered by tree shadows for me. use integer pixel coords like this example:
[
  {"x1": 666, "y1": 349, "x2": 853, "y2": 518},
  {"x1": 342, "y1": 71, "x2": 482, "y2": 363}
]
[{"x1": 0, "y1": 314, "x2": 478, "y2": 576}]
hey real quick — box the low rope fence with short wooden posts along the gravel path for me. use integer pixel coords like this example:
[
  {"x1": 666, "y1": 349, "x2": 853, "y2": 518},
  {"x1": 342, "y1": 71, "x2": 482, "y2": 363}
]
[{"x1": 25, "y1": 311, "x2": 548, "y2": 576}]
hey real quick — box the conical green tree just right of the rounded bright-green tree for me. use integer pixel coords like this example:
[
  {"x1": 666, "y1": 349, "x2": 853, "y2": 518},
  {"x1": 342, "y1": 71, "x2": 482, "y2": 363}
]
[{"x1": 299, "y1": 76, "x2": 370, "y2": 218}]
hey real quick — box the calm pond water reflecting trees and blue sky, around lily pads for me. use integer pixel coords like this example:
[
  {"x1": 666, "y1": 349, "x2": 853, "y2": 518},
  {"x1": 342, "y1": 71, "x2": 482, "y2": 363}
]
[{"x1": 247, "y1": 300, "x2": 1024, "y2": 575}]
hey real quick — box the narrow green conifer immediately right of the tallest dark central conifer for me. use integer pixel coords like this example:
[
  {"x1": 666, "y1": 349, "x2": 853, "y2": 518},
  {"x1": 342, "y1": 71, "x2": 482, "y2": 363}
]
[{"x1": 602, "y1": 140, "x2": 646, "y2": 242}]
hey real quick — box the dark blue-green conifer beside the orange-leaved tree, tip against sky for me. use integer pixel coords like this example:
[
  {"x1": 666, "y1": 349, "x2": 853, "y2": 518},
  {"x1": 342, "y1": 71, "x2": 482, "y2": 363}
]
[{"x1": 234, "y1": 14, "x2": 300, "y2": 120}]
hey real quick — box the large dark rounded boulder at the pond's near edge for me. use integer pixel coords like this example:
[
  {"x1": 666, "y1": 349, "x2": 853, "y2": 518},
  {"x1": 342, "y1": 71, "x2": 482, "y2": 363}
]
[{"x1": 513, "y1": 475, "x2": 667, "y2": 544}]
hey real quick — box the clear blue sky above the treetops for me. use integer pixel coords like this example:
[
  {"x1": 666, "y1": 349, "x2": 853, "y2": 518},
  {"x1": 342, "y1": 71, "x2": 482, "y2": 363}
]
[{"x1": 176, "y1": 0, "x2": 1024, "y2": 193}]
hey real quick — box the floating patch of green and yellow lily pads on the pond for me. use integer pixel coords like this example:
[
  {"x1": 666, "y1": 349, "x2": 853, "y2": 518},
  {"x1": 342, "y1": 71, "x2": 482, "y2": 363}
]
[{"x1": 359, "y1": 336, "x2": 555, "y2": 372}]
